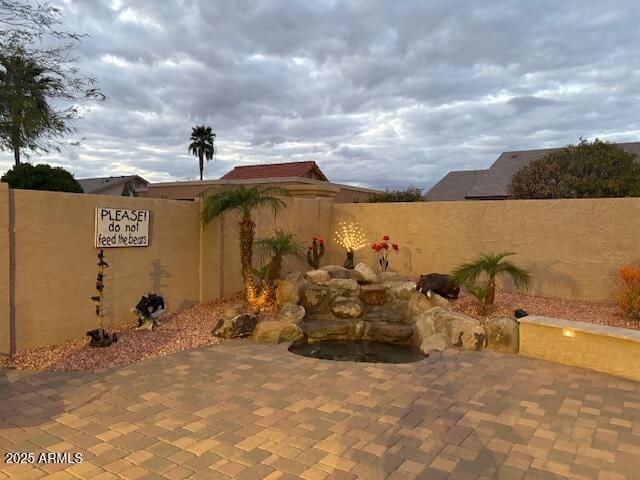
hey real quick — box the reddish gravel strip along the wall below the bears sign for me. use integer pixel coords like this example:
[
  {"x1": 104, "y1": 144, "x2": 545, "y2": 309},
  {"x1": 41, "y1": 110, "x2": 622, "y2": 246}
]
[{"x1": 0, "y1": 296, "x2": 248, "y2": 370}]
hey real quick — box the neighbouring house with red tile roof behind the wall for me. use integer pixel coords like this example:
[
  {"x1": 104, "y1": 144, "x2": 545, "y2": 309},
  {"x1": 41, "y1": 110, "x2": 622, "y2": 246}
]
[{"x1": 142, "y1": 161, "x2": 380, "y2": 203}]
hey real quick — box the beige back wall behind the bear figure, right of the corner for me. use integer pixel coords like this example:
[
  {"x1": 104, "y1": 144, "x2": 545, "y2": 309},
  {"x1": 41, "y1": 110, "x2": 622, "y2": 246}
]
[{"x1": 330, "y1": 198, "x2": 640, "y2": 301}]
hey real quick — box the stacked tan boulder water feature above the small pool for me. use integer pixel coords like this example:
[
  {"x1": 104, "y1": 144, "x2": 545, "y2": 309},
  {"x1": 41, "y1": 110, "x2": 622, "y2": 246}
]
[{"x1": 253, "y1": 263, "x2": 518, "y2": 361}]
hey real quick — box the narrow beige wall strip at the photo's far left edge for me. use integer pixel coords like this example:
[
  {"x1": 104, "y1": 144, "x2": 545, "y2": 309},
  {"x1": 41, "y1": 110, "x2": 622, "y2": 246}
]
[{"x1": 0, "y1": 182, "x2": 11, "y2": 355}]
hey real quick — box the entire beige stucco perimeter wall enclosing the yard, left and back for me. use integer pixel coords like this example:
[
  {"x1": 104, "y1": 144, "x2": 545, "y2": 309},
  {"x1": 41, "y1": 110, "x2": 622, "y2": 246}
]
[{"x1": 0, "y1": 188, "x2": 640, "y2": 353}]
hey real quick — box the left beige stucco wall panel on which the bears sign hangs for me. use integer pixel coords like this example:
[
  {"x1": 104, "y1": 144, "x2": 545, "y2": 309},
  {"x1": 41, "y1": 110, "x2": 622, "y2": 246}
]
[{"x1": 10, "y1": 190, "x2": 200, "y2": 350}]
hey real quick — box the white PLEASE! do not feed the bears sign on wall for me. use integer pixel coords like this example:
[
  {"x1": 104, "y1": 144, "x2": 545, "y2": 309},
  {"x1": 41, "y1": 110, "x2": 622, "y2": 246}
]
[{"x1": 96, "y1": 207, "x2": 150, "y2": 248}]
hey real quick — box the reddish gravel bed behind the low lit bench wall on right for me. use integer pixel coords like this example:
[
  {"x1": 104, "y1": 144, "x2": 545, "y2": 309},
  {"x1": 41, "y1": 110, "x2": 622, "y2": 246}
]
[{"x1": 451, "y1": 292, "x2": 640, "y2": 330}]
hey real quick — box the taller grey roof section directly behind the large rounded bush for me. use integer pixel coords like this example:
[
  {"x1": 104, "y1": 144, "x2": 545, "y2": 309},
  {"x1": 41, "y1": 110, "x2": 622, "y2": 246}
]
[{"x1": 466, "y1": 142, "x2": 640, "y2": 199}]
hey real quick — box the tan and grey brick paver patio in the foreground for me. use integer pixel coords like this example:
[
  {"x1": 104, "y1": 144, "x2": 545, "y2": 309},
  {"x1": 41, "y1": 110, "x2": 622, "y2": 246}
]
[{"x1": 0, "y1": 341, "x2": 640, "y2": 480}]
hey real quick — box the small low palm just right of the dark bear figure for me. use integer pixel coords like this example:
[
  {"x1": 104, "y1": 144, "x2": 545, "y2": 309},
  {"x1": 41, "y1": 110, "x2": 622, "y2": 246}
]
[{"x1": 451, "y1": 252, "x2": 531, "y2": 312}]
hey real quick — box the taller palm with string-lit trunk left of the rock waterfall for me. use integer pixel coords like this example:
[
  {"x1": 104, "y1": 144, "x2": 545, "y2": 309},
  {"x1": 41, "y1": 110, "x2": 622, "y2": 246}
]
[{"x1": 201, "y1": 186, "x2": 291, "y2": 295}]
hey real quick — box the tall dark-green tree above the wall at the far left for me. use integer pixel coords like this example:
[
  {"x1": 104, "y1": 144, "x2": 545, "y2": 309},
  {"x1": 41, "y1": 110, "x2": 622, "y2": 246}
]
[{"x1": 0, "y1": 49, "x2": 63, "y2": 166}]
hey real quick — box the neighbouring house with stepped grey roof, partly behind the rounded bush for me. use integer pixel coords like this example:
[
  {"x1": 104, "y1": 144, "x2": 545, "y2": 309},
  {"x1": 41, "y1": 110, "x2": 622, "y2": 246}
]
[{"x1": 425, "y1": 142, "x2": 640, "y2": 201}]
